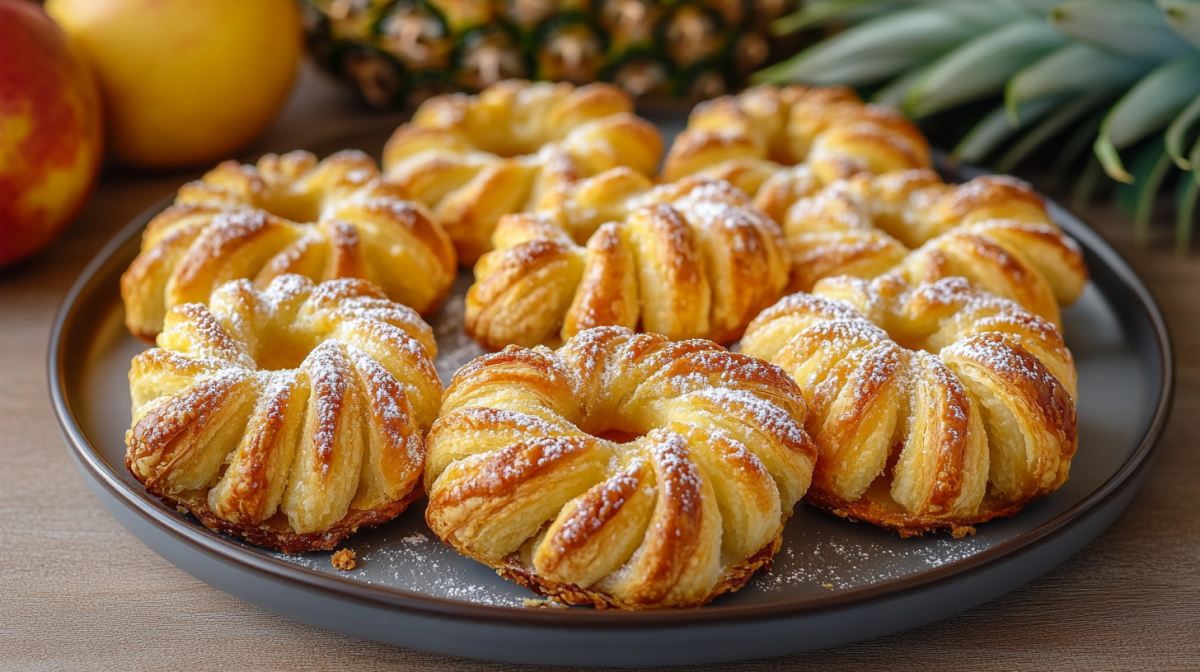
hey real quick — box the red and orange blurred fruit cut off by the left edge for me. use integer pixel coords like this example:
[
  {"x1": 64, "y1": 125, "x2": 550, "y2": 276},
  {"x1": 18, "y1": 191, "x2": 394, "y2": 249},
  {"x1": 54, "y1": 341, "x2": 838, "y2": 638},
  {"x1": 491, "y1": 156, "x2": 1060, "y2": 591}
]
[{"x1": 0, "y1": 0, "x2": 103, "y2": 266}]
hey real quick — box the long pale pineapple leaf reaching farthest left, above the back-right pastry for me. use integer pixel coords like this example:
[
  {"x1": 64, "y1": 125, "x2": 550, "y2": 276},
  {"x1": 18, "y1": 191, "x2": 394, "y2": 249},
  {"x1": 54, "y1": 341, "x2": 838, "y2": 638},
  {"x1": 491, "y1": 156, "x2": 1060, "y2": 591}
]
[{"x1": 752, "y1": 7, "x2": 989, "y2": 86}]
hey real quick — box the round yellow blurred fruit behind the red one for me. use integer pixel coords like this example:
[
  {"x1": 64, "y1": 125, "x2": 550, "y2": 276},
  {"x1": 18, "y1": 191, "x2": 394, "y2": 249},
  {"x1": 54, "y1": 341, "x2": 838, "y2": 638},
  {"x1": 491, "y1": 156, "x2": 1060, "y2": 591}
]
[{"x1": 46, "y1": 0, "x2": 304, "y2": 168}]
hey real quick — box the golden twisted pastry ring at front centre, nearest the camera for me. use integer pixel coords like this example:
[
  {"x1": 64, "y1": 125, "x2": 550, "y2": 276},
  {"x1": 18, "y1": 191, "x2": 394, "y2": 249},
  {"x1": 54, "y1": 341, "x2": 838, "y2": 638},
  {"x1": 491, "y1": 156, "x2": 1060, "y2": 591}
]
[{"x1": 425, "y1": 328, "x2": 815, "y2": 610}]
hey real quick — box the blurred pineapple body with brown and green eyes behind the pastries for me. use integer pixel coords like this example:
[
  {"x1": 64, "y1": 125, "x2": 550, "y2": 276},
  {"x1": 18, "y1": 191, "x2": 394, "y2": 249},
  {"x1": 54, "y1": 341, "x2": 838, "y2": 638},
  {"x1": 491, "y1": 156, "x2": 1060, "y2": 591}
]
[{"x1": 302, "y1": 0, "x2": 799, "y2": 107}]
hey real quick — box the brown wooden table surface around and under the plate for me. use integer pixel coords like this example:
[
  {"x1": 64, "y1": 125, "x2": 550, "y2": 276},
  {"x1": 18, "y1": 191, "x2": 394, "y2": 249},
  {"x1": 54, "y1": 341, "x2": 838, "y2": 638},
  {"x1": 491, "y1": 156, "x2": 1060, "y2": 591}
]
[{"x1": 0, "y1": 64, "x2": 1200, "y2": 672}]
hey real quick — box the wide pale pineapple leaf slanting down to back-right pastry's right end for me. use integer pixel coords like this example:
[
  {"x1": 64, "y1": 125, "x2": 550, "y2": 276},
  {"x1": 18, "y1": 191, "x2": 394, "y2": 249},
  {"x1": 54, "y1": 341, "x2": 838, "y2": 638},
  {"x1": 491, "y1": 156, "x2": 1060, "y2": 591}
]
[{"x1": 905, "y1": 19, "x2": 1067, "y2": 118}]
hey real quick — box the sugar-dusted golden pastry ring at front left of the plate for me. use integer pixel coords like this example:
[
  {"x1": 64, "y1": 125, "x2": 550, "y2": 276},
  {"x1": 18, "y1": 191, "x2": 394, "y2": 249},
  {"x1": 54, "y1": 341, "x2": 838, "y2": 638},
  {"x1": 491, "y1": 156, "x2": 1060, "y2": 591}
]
[{"x1": 125, "y1": 275, "x2": 442, "y2": 553}]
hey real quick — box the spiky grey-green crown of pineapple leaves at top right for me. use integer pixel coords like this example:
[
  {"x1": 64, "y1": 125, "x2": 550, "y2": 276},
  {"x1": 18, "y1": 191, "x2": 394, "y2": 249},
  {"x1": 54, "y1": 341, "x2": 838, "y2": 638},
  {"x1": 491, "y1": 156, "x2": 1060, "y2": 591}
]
[{"x1": 755, "y1": 0, "x2": 1200, "y2": 250}]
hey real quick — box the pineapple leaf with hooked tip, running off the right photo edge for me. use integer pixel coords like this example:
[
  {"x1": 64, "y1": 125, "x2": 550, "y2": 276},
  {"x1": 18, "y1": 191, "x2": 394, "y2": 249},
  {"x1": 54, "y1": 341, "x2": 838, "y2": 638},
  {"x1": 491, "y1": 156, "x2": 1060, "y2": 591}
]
[{"x1": 1094, "y1": 53, "x2": 1200, "y2": 182}]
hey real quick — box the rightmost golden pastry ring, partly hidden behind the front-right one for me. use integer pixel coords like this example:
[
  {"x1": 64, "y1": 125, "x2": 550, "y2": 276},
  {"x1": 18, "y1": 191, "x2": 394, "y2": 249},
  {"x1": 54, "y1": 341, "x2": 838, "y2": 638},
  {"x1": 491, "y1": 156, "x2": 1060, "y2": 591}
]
[{"x1": 756, "y1": 169, "x2": 1087, "y2": 325}]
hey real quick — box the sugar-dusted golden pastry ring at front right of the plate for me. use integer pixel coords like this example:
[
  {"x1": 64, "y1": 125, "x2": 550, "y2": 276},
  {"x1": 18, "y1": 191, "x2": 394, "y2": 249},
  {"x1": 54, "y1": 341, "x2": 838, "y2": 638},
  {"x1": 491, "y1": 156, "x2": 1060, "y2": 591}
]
[{"x1": 742, "y1": 275, "x2": 1078, "y2": 536}]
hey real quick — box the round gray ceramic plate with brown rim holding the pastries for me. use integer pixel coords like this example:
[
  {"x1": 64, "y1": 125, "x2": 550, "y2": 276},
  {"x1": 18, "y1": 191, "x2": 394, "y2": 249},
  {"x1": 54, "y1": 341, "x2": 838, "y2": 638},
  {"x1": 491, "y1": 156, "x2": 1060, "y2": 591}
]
[{"x1": 49, "y1": 121, "x2": 1172, "y2": 665}]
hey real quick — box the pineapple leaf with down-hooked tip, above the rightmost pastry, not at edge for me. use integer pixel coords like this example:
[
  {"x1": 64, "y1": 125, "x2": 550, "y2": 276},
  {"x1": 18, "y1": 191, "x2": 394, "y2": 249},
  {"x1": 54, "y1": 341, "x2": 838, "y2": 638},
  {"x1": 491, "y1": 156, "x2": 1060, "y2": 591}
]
[{"x1": 1004, "y1": 43, "x2": 1153, "y2": 124}]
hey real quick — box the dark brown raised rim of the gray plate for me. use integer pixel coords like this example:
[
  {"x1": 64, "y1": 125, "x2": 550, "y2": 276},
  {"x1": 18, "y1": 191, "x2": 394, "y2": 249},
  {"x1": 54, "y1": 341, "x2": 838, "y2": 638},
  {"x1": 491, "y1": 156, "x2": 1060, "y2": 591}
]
[{"x1": 47, "y1": 178, "x2": 1175, "y2": 630}]
